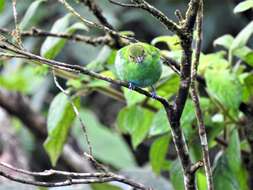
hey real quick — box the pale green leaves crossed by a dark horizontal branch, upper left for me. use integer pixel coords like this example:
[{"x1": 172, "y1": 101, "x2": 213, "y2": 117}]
[{"x1": 40, "y1": 14, "x2": 87, "y2": 59}]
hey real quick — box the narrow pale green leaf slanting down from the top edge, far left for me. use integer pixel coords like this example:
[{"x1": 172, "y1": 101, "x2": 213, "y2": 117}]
[{"x1": 19, "y1": 0, "x2": 45, "y2": 30}]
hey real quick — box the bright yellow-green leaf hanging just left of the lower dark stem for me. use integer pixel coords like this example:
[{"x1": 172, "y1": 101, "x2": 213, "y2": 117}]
[{"x1": 149, "y1": 135, "x2": 171, "y2": 174}]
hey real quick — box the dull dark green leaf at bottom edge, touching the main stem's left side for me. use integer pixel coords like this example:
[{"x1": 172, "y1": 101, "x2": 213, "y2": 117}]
[{"x1": 170, "y1": 159, "x2": 184, "y2": 190}]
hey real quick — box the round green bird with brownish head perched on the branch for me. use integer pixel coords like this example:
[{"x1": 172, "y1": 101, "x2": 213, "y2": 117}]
[{"x1": 115, "y1": 43, "x2": 162, "y2": 97}]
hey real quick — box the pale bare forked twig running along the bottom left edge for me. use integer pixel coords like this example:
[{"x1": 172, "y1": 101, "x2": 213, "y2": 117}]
[{"x1": 0, "y1": 162, "x2": 151, "y2": 190}]
